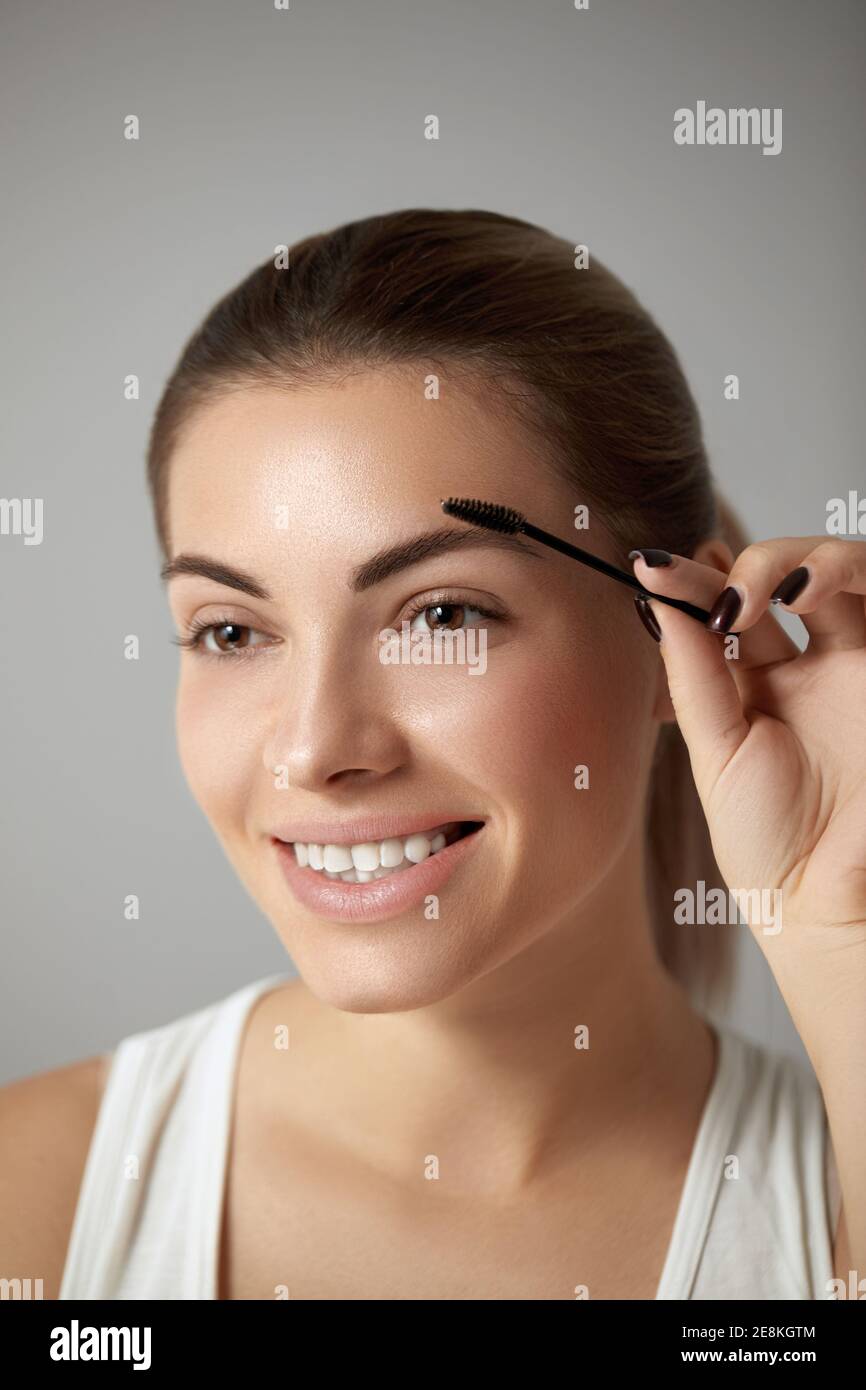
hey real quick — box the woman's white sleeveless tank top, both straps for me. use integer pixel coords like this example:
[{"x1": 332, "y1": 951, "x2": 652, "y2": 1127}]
[{"x1": 58, "y1": 974, "x2": 841, "y2": 1300}]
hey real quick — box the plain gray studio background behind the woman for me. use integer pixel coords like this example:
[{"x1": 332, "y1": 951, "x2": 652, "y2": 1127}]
[{"x1": 0, "y1": 0, "x2": 866, "y2": 1079}]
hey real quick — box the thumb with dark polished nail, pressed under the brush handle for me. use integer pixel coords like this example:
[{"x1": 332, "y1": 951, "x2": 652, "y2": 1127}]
[{"x1": 635, "y1": 598, "x2": 749, "y2": 791}]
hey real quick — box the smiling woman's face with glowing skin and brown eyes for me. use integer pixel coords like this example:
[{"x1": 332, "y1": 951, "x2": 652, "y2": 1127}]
[{"x1": 168, "y1": 368, "x2": 659, "y2": 1013}]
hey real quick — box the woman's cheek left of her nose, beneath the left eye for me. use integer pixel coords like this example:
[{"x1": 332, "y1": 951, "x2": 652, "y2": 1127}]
[{"x1": 175, "y1": 664, "x2": 263, "y2": 837}]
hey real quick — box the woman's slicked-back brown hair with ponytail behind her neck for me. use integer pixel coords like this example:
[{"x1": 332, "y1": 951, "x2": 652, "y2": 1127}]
[{"x1": 147, "y1": 209, "x2": 746, "y2": 999}]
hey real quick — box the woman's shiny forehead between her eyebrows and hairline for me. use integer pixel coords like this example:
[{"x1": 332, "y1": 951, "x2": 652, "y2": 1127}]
[{"x1": 168, "y1": 367, "x2": 562, "y2": 553}]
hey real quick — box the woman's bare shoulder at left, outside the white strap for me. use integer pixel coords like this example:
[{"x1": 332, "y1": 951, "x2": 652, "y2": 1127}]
[{"x1": 0, "y1": 1054, "x2": 111, "y2": 1298}]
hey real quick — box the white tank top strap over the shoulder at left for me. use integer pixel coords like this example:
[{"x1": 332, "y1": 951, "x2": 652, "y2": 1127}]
[{"x1": 58, "y1": 974, "x2": 291, "y2": 1298}]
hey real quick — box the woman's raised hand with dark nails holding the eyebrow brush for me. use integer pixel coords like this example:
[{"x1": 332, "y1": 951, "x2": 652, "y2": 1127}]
[{"x1": 634, "y1": 537, "x2": 866, "y2": 958}]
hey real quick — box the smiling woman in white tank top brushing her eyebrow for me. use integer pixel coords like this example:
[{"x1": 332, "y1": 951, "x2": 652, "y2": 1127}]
[{"x1": 3, "y1": 210, "x2": 866, "y2": 1300}]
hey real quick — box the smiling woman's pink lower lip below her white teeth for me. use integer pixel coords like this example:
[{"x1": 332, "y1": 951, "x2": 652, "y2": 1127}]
[{"x1": 272, "y1": 828, "x2": 481, "y2": 922}]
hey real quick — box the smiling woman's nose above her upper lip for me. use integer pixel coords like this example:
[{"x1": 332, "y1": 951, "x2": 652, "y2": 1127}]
[{"x1": 263, "y1": 649, "x2": 407, "y2": 791}]
